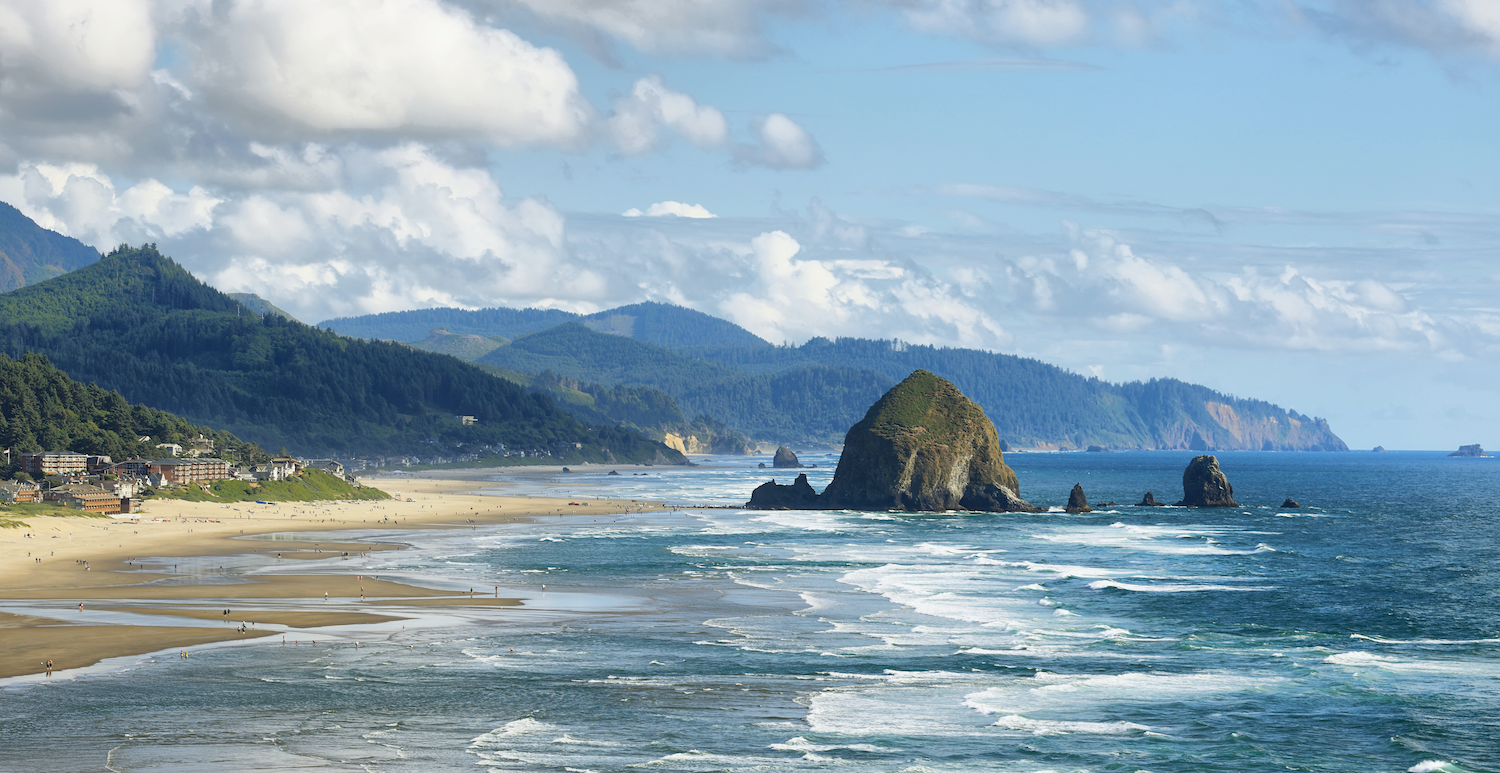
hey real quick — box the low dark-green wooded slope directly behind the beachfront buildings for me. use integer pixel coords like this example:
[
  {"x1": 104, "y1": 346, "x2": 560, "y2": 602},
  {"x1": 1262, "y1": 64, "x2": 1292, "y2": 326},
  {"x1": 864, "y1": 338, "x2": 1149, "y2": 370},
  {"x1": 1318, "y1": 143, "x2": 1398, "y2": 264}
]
[{"x1": 0, "y1": 354, "x2": 270, "y2": 464}]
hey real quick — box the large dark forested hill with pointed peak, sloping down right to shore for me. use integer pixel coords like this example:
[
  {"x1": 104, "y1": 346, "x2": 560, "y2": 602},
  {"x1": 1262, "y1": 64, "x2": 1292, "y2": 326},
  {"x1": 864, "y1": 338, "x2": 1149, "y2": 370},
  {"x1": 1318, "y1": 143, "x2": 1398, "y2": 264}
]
[{"x1": 0, "y1": 245, "x2": 686, "y2": 462}]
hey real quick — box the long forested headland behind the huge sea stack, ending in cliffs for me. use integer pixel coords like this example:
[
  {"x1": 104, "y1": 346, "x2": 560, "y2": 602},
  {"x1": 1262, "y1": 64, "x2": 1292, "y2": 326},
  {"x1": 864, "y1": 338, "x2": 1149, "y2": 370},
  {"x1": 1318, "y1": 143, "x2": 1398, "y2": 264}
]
[{"x1": 480, "y1": 323, "x2": 1347, "y2": 450}]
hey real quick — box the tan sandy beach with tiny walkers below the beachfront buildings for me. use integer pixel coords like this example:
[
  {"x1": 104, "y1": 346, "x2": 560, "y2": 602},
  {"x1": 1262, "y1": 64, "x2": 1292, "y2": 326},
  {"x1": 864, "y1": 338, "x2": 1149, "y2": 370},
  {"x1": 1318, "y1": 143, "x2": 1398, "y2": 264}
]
[{"x1": 0, "y1": 470, "x2": 660, "y2": 678}]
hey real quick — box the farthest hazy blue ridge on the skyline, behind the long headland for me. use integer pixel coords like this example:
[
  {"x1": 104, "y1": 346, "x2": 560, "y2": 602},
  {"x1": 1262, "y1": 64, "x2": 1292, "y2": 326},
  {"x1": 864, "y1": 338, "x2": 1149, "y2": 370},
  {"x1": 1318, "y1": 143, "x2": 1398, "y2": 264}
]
[{"x1": 318, "y1": 303, "x2": 771, "y2": 348}]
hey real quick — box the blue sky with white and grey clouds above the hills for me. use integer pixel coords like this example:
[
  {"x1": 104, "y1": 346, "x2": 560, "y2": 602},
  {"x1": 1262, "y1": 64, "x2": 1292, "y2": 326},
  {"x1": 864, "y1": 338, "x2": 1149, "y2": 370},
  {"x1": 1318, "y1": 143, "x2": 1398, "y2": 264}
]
[{"x1": 0, "y1": 0, "x2": 1500, "y2": 449}]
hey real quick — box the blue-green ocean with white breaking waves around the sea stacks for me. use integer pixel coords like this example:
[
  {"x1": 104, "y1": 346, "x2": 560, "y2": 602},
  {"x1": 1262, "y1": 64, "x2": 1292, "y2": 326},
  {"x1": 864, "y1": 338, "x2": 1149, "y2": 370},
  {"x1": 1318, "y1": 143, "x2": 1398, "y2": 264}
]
[{"x1": 0, "y1": 452, "x2": 1500, "y2": 773}]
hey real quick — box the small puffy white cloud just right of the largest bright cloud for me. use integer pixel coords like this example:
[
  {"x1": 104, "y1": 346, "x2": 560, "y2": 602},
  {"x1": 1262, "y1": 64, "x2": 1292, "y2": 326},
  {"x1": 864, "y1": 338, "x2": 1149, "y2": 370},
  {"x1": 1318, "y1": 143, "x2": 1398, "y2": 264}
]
[{"x1": 606, "y1": 75, "x2": 729, "y2": 153}]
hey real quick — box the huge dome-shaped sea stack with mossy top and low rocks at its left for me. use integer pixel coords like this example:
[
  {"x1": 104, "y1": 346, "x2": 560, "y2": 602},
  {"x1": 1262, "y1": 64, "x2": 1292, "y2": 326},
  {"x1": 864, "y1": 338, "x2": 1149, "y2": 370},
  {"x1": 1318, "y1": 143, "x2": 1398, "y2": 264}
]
[{"x1": 746, "y1": 371, "x2": 1043, "y2": 512}]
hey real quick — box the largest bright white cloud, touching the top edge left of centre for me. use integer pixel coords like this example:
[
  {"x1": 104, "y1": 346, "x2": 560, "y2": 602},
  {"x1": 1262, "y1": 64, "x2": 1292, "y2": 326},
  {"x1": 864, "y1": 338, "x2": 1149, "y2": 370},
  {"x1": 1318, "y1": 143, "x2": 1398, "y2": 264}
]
[{"x1": 191, "y1": 0, "x2": 591, "y2": 146}]
